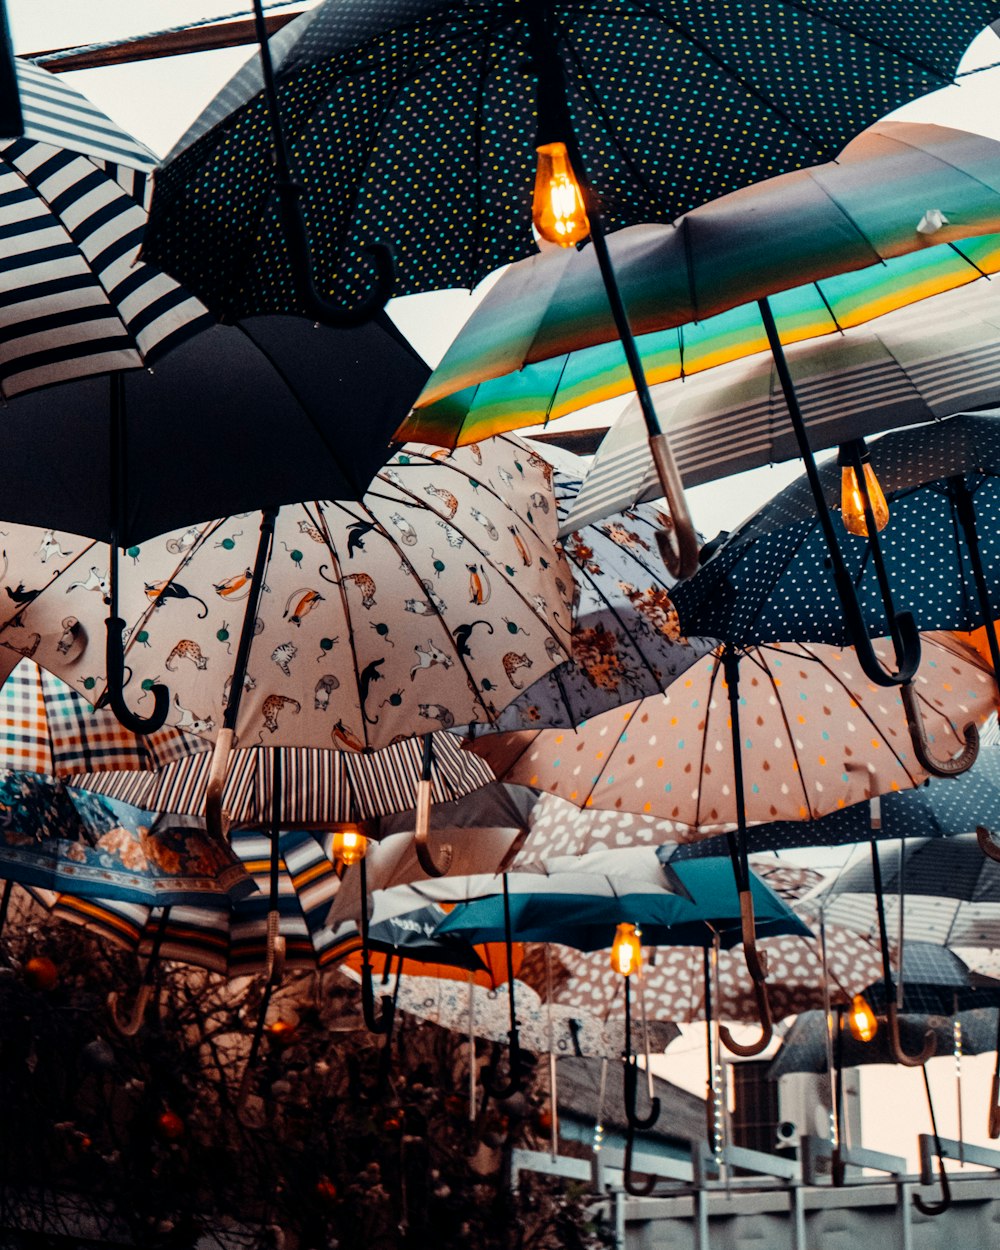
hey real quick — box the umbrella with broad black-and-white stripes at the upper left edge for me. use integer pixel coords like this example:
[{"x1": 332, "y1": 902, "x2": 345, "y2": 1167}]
[{"x1": 0, "y1": 61, "x2": 213, "y2": 396}]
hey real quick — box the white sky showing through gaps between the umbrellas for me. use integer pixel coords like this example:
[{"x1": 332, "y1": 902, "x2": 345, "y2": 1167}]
[{"x1": 8, "y1": 0, "x2": 1000, "y2": 1164}]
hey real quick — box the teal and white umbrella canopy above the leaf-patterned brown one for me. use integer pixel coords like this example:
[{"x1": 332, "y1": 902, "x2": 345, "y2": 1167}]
[{"x1": 432, "y1": 846, "x2": 809, "y2": 950}]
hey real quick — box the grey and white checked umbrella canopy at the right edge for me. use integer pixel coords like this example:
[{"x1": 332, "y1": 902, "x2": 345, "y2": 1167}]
[{"x1": 804, "y1": 840, "x2": 1000, "y2": 946}]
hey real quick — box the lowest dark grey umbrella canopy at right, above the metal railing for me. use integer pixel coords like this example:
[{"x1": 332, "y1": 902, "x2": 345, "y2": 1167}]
[{"x1": 768, "y1": 1008, "x2": 996, "y2": 1080}]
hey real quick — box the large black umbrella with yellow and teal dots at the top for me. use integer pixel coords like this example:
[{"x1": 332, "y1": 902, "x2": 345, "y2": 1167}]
[{"x1": 151, "y1": 0, "x2": 1000, "y2": 574}]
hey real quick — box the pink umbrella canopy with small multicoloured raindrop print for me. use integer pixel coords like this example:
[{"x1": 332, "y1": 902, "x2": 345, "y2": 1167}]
[{"x1": 468, "y1": 635, "x2": 995, "y2": 831}]
